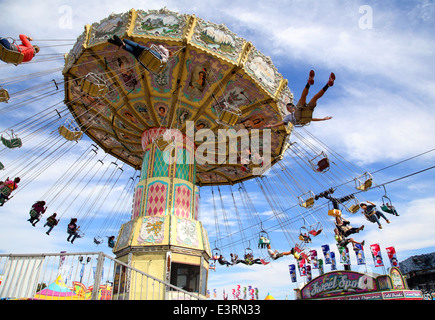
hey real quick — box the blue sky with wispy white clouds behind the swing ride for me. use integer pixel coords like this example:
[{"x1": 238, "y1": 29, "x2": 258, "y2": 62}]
[{"x1": 0, "y1": 0, "x2": 435, "y2": 299}]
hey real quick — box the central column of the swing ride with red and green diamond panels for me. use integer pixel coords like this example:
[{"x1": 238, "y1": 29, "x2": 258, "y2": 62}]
[{"x1": 113, "y1": 128, "x2": 210, "y2": 300}]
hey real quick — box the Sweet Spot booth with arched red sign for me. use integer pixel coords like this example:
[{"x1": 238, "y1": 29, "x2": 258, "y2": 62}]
[{"x1": 295, "y1": 267, "x2": 423, "y2": 300}]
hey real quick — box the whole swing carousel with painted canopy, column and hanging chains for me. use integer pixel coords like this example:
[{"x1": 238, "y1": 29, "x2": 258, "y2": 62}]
[{"x1": 0, "y1": 8, "x2": 402, "y2": 298}]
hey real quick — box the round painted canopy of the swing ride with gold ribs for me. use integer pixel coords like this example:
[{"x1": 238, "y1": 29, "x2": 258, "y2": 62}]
[{"x1": 63, "y1": 8, "x2": 293, "y2": 185}]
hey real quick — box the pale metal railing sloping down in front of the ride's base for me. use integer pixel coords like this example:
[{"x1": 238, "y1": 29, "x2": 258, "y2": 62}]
[{"x1": 0, "y1": 252, "x2": 205, "y2": 300}]
